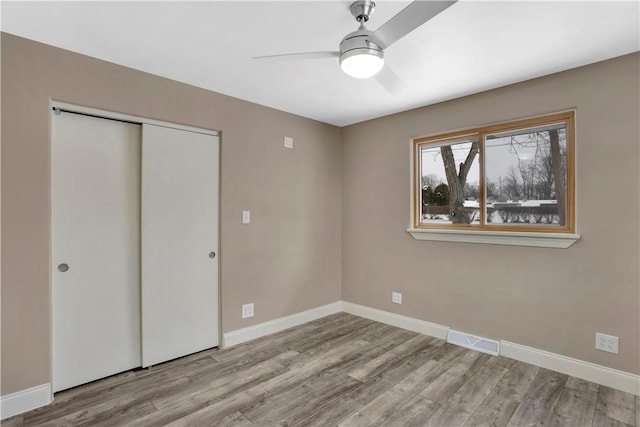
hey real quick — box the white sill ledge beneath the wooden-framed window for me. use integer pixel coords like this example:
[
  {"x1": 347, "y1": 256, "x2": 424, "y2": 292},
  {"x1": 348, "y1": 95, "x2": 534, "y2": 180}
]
[{"x1": 407, "y1": 228, "x2": 580, "y2": 249}]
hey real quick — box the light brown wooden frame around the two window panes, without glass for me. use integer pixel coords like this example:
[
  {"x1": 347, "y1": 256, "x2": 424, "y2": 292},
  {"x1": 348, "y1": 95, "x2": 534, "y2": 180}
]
[{"x1": 409, "y1": 111, "x2": 579, "y2": 237}]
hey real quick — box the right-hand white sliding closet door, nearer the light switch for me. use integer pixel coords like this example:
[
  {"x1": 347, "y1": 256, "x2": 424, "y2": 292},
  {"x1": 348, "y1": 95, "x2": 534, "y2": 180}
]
[{"x1": 141, "y1": 124, "x2": 219, "y2": 366}]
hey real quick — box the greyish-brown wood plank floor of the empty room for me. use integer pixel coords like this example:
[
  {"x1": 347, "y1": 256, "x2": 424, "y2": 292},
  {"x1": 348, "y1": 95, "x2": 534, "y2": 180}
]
[{"x1": 2, "y1": 313, "x2": 640, "y2": 427}]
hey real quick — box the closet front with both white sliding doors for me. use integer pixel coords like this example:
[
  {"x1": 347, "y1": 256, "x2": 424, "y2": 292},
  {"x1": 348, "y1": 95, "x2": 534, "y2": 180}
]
[{"x1": 51, "y1": 109, "x2": 219, "y2": 391}]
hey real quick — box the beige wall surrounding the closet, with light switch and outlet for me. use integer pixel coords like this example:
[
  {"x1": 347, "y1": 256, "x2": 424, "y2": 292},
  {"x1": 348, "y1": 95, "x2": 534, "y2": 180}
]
[{"x1": 1, "y1": 34, "x2": 341, "y2": 395}]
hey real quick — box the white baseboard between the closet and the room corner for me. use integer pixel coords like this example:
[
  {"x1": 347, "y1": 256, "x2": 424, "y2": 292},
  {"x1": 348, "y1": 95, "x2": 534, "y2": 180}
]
[{"x1": 222, "y1": 301, "x2": 342, "y2": 348}]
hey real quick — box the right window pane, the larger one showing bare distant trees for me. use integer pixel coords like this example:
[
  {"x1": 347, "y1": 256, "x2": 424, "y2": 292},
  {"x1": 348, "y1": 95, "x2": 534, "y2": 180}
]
[{"x1": 484, "y1": 123, "x2": 567, "y2": 226}]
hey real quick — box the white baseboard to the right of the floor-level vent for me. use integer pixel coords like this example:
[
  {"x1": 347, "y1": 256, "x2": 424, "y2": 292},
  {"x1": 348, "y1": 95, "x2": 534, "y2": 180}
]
[{"x1": 500, "y1": 341, "x2": 640, "y2": 396}]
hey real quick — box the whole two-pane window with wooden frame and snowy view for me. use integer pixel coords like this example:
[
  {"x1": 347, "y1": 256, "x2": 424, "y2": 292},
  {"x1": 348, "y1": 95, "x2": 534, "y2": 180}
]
[{"x1": 409, "y1": 111, "x2": 579, "y2": 247}]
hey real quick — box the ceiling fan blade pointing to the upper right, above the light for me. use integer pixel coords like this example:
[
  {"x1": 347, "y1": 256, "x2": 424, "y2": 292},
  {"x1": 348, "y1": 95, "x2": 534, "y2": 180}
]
[{"x1": 373, "y1": 0, "x2": 457, "y2": 49}]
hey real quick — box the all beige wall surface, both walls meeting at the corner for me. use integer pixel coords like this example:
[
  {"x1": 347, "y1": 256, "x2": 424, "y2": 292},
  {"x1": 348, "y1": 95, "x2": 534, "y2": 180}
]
[{"x1": 1, "y1": 34, "x2": 640, "y2": 395}]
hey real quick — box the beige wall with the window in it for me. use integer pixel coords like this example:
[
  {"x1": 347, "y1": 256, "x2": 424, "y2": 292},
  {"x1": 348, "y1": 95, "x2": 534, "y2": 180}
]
[{"x1": 342, "y1": 54, "x2": 640, "y2": 374}]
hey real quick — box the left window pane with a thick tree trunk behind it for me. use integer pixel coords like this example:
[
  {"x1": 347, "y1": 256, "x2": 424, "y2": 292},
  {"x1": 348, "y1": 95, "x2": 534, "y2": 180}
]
[{"x1": 420, "y1": 140, "x2": 480, "y2": 224}]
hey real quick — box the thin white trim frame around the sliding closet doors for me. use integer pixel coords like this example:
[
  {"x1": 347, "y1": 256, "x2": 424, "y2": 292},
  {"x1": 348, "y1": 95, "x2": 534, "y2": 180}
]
[{"x1": 49, "y1": 99, "x2": 224, "y2": 392}]
